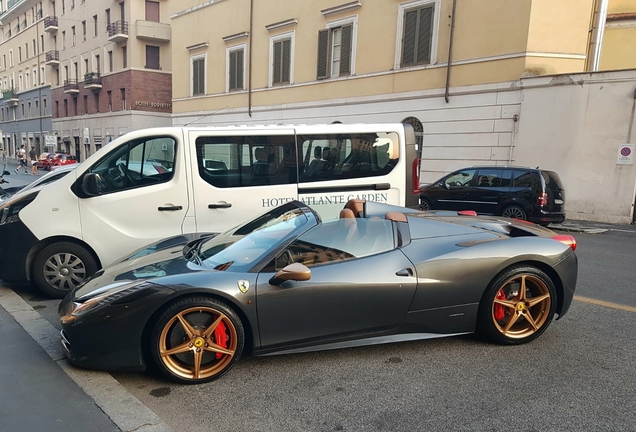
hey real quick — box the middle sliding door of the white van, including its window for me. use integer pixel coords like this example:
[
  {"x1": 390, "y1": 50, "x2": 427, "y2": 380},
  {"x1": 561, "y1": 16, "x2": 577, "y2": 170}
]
[{"x1": 189, "y1": 128, "x2": 298, "y2": 232}]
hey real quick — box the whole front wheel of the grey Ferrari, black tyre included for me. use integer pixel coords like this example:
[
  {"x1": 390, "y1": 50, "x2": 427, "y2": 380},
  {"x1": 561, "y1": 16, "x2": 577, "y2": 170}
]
[{"x1": 150, "y1": 297, "x2": 245, "y2": 384}]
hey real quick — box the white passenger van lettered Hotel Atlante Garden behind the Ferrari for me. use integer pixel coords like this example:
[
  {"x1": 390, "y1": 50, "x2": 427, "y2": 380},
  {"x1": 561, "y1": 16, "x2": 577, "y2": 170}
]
[{"x1": 0, "y1": 124, "x2": 419, "y2": 297}]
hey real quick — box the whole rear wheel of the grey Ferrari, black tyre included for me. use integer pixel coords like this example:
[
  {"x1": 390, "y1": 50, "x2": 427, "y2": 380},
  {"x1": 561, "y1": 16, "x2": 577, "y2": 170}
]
[{"x1": 477, "y1": 266, "x2": 557, "y2": 345}]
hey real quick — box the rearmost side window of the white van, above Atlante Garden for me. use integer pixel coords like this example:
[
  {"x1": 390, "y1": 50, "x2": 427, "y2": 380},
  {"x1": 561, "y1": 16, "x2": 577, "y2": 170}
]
[{"x1": 297, "y1": 132, "x2": 400, "y2": 183}]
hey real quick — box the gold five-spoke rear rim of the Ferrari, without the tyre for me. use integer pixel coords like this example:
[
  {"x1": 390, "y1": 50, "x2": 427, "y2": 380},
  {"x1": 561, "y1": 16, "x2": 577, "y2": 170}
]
[{"x1": 492, "y1": 274, "x2": 552, "y2": 339}]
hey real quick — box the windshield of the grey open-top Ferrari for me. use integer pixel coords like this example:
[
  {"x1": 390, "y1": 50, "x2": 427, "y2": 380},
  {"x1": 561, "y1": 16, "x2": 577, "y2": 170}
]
[{"x1": 198, "y1": 203, "x2": 317, "y2": 272}]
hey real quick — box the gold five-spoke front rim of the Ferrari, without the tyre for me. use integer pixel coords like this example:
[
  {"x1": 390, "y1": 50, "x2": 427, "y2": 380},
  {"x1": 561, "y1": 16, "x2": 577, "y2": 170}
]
[{"x1": 159, "y1": 306, "x2": 237, "y2": 380}]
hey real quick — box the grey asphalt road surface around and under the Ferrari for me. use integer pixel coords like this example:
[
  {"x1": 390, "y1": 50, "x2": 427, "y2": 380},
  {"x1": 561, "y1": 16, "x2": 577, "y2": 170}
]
[{"x1": 6, "y1": 226, "x2": 636, "y2": 431}]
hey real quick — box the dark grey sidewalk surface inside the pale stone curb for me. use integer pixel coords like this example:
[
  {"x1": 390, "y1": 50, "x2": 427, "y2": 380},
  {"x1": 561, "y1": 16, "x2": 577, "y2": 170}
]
[{"x1": 0, "y1": 306, "x2": 120, "y2": 432}]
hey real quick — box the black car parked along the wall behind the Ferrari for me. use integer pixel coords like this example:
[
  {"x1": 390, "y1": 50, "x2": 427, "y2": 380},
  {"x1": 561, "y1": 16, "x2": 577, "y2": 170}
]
[{"x1": 420, "y1": 166, "x2": 565, "y2": 225}]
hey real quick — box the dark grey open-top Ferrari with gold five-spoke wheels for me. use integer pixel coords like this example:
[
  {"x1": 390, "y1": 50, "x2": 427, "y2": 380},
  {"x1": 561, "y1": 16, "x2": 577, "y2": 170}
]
[{"x1": 59, "y1": 200, "x2": 577, "y2": 383}]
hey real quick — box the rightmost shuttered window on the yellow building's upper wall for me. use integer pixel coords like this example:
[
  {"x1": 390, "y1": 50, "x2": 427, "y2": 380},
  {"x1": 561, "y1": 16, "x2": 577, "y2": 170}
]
[{"x1": 400, "y1": 4, "x2": 435, "y2": 67}]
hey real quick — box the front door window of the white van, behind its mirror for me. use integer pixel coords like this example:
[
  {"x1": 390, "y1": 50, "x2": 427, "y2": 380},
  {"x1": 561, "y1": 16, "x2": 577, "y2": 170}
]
[{"x1": 89, "y1": 137, "x2": 177, "y2": 194}]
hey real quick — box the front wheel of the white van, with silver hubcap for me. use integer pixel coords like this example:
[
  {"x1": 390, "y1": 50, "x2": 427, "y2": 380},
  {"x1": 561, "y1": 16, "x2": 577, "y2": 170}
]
[{"x1": 33, "y1": 242, "x2": 98, "y2": 298}]
